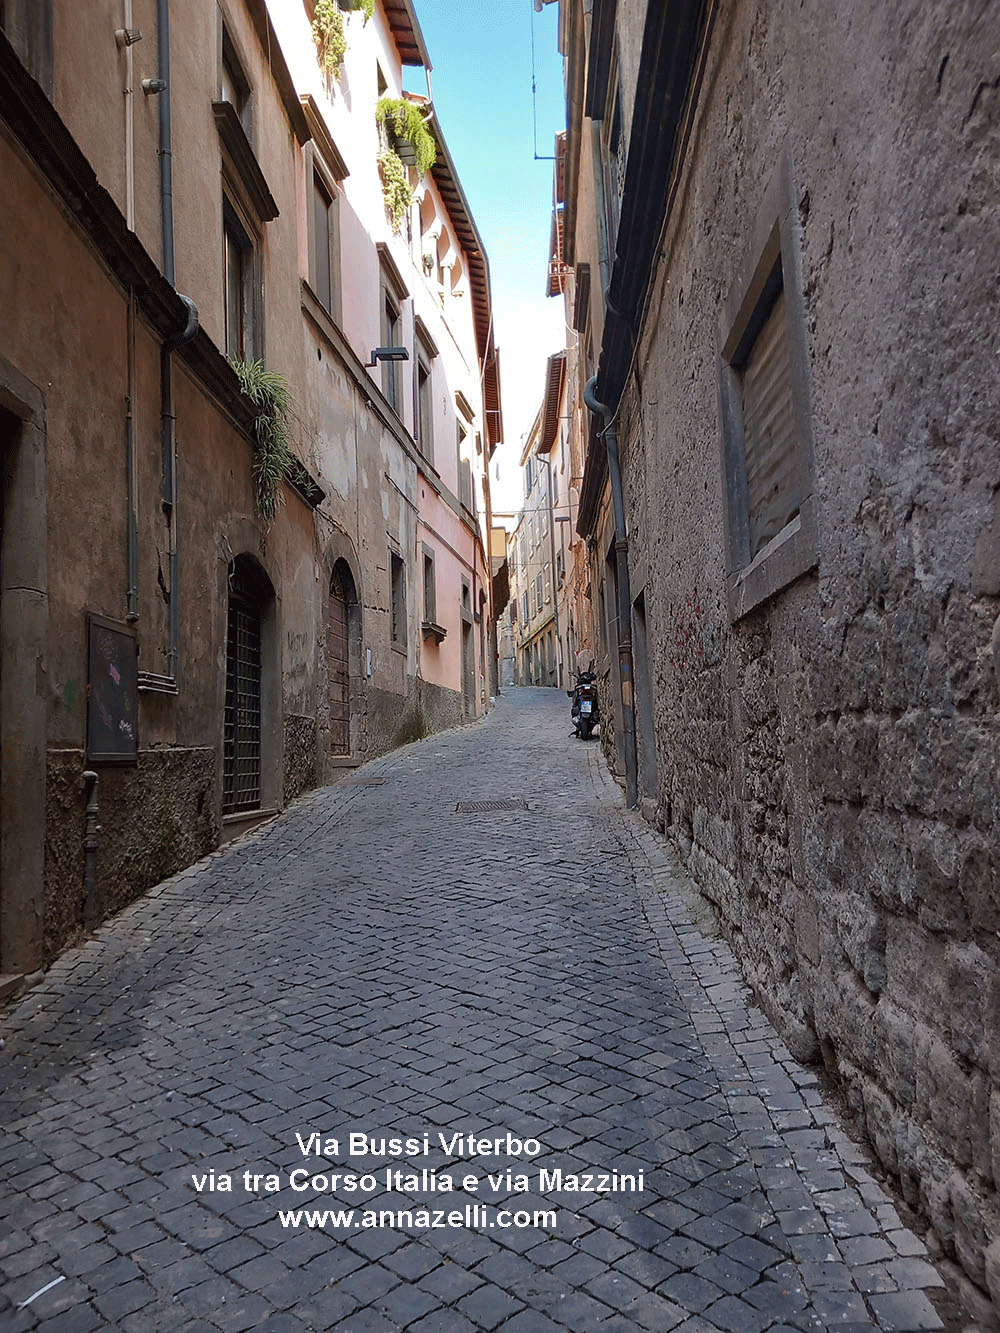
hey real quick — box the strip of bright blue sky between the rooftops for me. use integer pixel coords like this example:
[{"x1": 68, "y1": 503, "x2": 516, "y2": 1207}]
[{"x1": 407, "y1": 0, "x2": 565, "y2": 508}]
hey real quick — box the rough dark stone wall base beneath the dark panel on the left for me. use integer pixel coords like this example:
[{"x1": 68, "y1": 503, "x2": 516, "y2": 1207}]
[{"x1": 44, "y1": 749, "x2": 220, "y2": 965}]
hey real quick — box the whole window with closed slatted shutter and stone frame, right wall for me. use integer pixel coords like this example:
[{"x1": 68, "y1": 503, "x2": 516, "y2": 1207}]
[{"x1": 719, "y1": 151, "x2": 817, "y2": 620}]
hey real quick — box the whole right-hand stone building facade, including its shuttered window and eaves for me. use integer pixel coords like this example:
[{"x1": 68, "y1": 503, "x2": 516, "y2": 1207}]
[{"x1": 561, "y1": 0, "x2": 1000, "y2": 1301}]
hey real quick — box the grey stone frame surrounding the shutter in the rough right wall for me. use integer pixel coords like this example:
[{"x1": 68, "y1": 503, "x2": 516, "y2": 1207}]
[{"x1": 719, "y1": 144, "x2": 819, "y2": 623}]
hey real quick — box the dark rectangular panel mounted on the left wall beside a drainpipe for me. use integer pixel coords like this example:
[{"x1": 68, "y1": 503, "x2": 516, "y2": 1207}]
[{"x1": 87, "y1": 616, "x2": 139, "y2": 764}]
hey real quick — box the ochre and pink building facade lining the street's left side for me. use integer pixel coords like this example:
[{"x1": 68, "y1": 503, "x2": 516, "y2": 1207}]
[{"x1": 0, "y1": 0, "x2": 501, "y2": 990}]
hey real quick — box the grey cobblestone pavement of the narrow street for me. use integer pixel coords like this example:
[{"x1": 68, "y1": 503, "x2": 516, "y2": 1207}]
[{"x1": 0, "y1": 690, "x2": 960, "y2": 1333}]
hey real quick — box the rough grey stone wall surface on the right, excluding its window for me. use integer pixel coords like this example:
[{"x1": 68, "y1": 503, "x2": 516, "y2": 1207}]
[{"x1": 627, "y1": 0, "x2": 1000, "y2": 1298}]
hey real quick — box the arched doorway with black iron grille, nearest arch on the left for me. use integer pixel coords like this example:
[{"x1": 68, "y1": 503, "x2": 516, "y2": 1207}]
[{"x1": 223, "y1": 556, "x2": 275, "y2": 814}]
